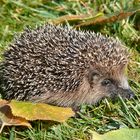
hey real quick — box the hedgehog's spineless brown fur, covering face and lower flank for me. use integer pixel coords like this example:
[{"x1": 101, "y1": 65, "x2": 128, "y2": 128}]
[{"x1": 31, "y1": 64, "x2": 133, "y2": 107}]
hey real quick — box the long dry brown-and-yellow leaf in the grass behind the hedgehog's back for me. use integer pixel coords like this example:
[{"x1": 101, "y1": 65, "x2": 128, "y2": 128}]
[{"x1": 51, "y1": 10, "x2": 137, "y2": 28}]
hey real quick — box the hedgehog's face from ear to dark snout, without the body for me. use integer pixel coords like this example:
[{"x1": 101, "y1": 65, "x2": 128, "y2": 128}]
[{"x1": 88, "y1": 67, "x2": 134, "y2": 103}]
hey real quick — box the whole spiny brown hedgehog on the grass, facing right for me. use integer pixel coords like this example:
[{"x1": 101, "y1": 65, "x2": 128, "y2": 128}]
[{"x1": 0, "y1": 24, "x2": 134, "y2": 107}]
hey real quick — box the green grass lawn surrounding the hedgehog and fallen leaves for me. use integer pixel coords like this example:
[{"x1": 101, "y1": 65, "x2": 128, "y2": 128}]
[{"x1": 0, "y1": 0, "x2": 140, "y2": 140}]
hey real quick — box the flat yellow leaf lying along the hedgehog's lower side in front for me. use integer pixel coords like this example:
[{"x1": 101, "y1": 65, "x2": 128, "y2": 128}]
[{"x1": 9, "y1": 100, "x2": 74, "y2": 122}]
